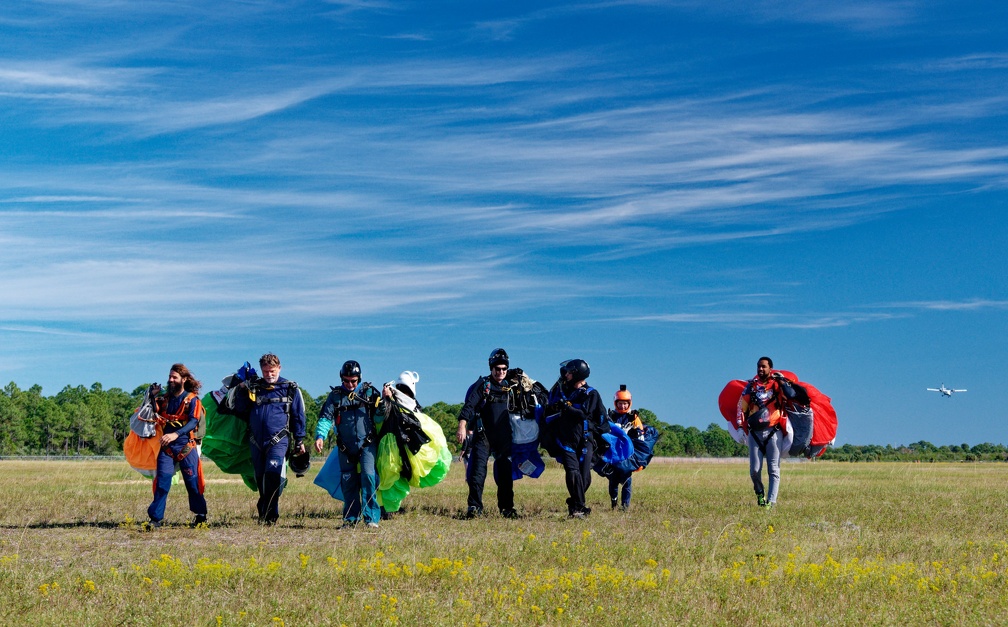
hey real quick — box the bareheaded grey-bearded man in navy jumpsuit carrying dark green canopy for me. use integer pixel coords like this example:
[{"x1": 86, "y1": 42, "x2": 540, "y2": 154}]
[{"x1": 235, "y1": 353, "x2": 305, "y2": 525}]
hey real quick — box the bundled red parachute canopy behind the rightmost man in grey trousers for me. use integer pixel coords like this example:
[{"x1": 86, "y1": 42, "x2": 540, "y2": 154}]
[{"x1": 718, "y1": 370, "x2": 837, "y2": 458}]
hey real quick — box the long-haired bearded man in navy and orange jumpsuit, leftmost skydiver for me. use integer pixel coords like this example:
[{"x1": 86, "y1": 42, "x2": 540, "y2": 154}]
[{"x1": 147, "y1": 364, "x2": 207, "y2": 528}]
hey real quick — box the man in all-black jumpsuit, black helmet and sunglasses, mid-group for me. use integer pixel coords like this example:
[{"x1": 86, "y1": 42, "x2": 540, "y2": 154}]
[{"x1": 457, "y1": 349, "x2": 518, "y2": 518}]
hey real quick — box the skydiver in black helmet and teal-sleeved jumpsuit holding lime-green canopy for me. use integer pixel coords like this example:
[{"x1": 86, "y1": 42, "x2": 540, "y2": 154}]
[{"x1": 316, "y1": 360, "x2": 384, "y2": 528}]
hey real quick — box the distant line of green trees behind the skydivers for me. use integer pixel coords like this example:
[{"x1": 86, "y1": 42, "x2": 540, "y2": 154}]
[{"x1": 0, "y1": 382, "x2": 1008, "y2": 462}]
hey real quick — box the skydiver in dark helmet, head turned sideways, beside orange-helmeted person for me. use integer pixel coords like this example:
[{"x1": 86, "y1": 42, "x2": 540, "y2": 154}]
[{"x1": 545, "y1": 359, "x2": 606, "y2": 518}]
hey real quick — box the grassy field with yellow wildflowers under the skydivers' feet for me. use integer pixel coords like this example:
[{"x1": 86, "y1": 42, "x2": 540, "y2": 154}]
[{"x1": 0, "y1": 461, "x2": 1008, "y2": 626}]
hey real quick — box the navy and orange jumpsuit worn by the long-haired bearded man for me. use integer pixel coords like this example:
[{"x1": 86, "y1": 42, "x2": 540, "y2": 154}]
[{"x1": 147, "y1": 392, "x2": 207, "y2": 522}]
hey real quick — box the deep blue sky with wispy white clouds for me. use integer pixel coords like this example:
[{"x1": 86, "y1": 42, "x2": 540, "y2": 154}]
[{"x1": 0, "y1": 0, "x2": 1008, "y2": 445}]
